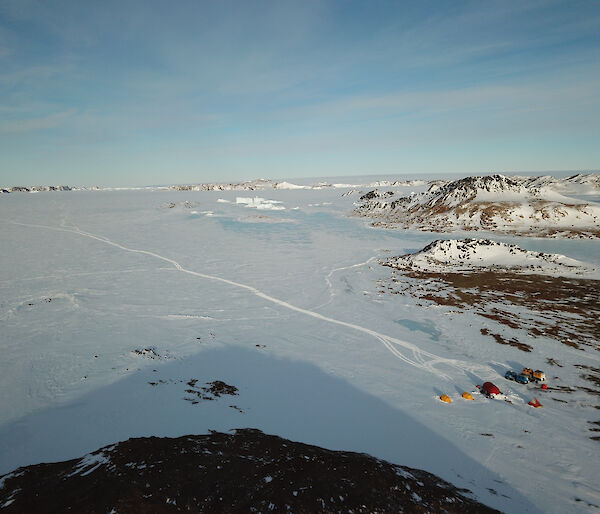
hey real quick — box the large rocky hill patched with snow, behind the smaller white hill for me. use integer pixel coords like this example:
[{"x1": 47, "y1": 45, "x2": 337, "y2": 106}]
[{"x1": 354, "y1": 175, "x2": 600, "y2": 238}]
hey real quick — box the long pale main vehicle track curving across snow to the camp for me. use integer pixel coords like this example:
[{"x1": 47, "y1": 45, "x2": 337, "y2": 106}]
[{"x1": 10, "y1": 221, "x2": 493, "y2": 380}]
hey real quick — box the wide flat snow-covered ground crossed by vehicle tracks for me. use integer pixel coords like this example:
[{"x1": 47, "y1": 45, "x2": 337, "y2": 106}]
[{"x1": 0, "y1": 181, "x2": 600, "y2": 512}]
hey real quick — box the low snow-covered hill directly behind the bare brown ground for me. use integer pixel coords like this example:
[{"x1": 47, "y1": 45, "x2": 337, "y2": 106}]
[{"x1": 385, "y1": 239, "x2": 600, "y2": 279}]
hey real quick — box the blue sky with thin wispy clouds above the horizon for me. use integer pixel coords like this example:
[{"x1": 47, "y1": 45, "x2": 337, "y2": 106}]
[{"x1": 0, "y1": 0, "x2": 600, "y2": 186}]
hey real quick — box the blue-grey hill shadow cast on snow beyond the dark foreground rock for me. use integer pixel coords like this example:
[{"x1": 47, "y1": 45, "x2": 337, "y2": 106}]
[{"x1": 0, "y1": 346, "x2": 537, "y2": 512}]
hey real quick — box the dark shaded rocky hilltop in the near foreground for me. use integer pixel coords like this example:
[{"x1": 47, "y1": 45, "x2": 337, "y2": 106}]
[{"x1": 0, "y1": 429, "x2": 497, "y2": 514}]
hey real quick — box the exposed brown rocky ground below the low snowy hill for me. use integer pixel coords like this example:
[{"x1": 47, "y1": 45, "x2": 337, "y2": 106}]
[{"x1": 380, "y1": 270, "x2": 600, "y2": 351}]
